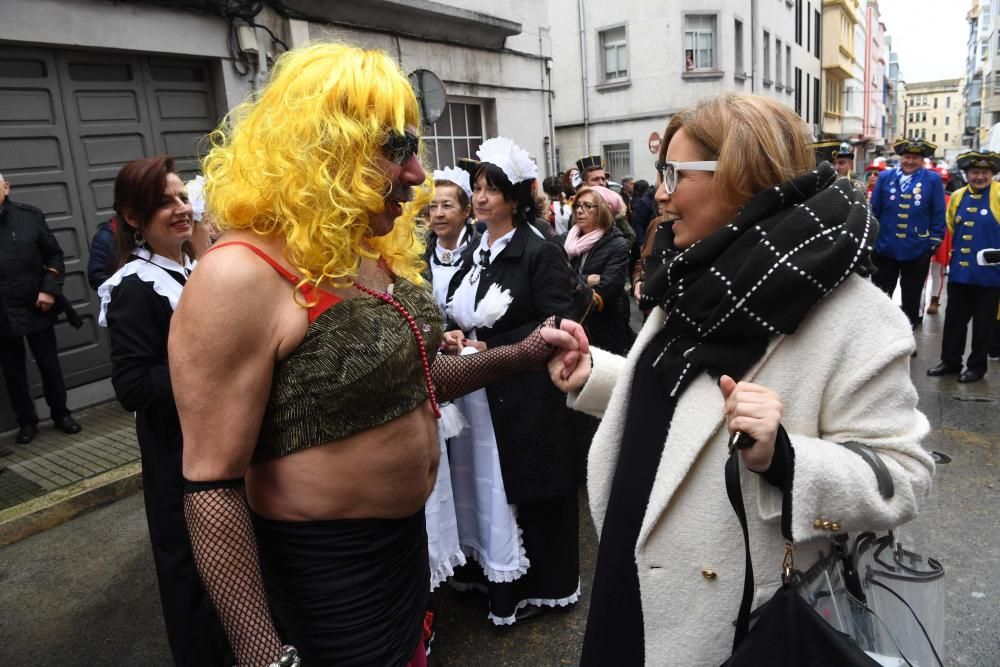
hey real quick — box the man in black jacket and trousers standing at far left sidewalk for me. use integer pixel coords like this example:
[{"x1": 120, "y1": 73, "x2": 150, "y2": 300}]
[{"x1": 0, "y1": 175, "x2": 80, "y2": 444}]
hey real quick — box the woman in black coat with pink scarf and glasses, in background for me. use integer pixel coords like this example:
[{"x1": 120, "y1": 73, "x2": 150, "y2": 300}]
[{"x1": 557, "y1": 186, "x2": 635, "y2": 356}]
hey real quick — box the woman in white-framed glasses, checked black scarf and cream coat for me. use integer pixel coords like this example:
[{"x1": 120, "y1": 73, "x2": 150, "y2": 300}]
[{"x1": 550, "y1": 94, "x2": 934, "y2": 667}]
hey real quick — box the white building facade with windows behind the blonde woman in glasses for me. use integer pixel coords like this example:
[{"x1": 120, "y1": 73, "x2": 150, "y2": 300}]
[{"x1": 549, "y1": 0, "x2": 820, "y2": 182}]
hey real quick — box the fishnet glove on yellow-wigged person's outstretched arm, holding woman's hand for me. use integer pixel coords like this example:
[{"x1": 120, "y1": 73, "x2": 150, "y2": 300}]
[{"x1": 431, "y1": 317, "x2": 559, "y2": 401}]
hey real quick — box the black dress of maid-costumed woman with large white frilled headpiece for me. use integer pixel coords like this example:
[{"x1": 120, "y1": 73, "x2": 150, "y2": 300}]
[{"x1": 449, "y1": 225, "x2": 581, "y2": 624}]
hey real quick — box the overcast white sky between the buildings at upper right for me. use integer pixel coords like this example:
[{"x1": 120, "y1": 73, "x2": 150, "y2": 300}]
[{"x1": 884, "y1": 0, "x2": 972, "y2": 83}]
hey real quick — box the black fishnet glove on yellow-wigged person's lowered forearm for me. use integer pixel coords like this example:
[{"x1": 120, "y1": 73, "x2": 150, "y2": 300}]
[{"x1": 184, "y1": 483, "x2": 281, "y2": 667}]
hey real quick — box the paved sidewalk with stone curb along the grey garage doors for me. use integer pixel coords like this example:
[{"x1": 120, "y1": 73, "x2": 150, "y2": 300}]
[{"x1": 0, "y1": 401, "x2": 141, "y2": 546}]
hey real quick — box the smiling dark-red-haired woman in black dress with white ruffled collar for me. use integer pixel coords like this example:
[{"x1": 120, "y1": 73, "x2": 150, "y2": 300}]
[{"x1": 98, "y1": 157, "x2": 229, "y2": 667}]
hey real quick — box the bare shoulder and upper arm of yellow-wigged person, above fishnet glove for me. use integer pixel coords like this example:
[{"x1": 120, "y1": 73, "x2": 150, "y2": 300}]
[{"x1": 167, "y1": 239, "x2": 308, "y2": 480}]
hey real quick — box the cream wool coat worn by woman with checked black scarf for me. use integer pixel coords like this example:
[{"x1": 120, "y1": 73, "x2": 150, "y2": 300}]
[{"x1": 569, "y1": 274, "x2": 934, "y2": 667}]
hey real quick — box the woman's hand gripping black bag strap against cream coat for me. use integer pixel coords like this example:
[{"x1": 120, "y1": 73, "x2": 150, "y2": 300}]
[{"x1": 719, "y1": 375, "x2": 783, "y2": 472}]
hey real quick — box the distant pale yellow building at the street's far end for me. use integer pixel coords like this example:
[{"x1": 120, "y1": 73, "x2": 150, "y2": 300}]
[{"x1": 903, "y1": 79, "x2": 965, "y2": 159}]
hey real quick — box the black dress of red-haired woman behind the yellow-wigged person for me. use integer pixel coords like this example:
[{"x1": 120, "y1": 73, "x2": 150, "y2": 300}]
[{"x1": 106, "y1": 255, "x2": 233, "y2": 667}]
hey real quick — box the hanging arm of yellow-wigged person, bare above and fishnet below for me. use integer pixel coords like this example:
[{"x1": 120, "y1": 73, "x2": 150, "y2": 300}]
[{"x1": 168, "y1": 248, "x2": 294, "y2": 667}]
